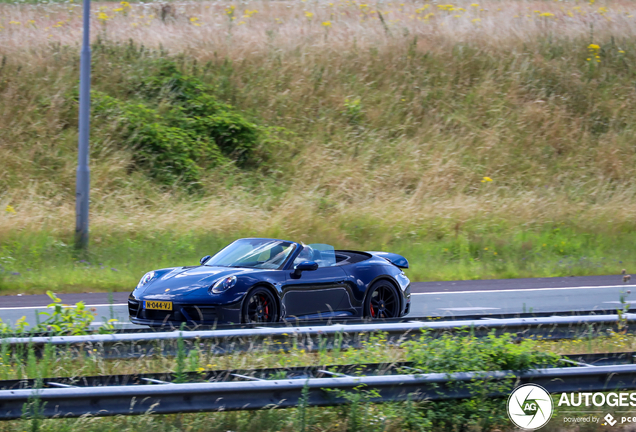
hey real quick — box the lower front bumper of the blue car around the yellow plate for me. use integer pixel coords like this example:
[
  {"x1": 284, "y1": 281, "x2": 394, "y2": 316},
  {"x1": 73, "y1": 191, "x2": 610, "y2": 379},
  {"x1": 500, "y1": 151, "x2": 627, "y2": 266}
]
[{"x1": 128, "y1": 298, "x2": 241, "y2": 327}]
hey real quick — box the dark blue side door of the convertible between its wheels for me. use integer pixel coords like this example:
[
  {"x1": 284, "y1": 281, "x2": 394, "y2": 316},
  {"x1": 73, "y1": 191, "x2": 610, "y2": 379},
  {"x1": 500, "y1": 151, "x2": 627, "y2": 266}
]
[{"x1": 282, "y1": 267, "x2": 349, "y2": 317}]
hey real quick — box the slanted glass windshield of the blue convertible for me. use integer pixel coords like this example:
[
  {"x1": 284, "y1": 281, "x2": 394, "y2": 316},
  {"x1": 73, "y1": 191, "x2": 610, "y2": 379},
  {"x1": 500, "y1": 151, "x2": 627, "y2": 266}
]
[{"x1": 205, "y1": 239, "x2": 295, "y2": 269}]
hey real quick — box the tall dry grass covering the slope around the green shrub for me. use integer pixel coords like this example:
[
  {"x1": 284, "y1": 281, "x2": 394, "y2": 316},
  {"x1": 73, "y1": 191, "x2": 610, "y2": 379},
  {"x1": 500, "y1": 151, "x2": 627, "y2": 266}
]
[{"x1": 0, "y1": 1, "x2": 636, "y2": 243}]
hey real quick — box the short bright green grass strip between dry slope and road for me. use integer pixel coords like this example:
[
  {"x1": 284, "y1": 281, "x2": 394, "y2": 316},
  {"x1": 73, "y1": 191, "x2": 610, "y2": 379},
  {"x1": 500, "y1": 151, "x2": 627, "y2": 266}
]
[{"x1": 0, "y1": 227, "x2": 636, "y2": 294}]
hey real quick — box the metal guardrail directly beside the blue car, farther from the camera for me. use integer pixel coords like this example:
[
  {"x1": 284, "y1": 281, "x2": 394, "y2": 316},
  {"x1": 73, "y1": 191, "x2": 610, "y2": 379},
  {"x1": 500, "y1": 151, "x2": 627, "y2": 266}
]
[{"x1": 2, "y1": 313, "x2": 636, "y2": 358}]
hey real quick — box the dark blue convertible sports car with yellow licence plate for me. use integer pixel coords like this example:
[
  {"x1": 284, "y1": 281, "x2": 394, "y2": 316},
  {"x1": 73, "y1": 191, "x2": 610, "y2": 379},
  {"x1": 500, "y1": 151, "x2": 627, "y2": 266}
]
[{"x1": 128, "y1": 238, "x2": 411, "y2": 326}]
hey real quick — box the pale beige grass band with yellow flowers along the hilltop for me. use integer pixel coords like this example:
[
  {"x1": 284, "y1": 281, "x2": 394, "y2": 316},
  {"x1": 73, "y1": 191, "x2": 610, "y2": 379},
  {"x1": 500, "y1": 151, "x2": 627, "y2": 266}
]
[{"x1": 0, "y1": 0, "x2": 636, "y2": 54}]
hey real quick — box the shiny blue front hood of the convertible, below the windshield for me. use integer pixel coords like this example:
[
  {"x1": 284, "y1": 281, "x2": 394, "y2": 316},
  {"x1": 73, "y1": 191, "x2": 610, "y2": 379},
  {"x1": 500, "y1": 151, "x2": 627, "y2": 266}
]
[{"x1": 135, "y1": 266, "x2": 263, "y2": 298}]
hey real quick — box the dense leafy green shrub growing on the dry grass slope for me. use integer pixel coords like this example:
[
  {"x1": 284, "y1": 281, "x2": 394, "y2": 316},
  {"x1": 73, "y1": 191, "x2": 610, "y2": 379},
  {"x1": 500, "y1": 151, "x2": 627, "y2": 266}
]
[{"x1": 93, "y1": 59, "x2": 271, "y2": 186}]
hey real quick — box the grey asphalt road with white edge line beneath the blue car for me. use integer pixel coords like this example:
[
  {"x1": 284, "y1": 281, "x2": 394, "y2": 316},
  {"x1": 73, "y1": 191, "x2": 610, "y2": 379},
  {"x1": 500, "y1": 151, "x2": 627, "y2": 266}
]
[{"x1": 0, "y1": 275, "x2": 636, "y2": 327}]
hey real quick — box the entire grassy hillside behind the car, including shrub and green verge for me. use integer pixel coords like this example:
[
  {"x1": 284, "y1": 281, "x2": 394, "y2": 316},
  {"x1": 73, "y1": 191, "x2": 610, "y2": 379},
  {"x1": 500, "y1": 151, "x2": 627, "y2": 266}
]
[{"x1": 0, "y1": 0, "x2": 636, "y2": 293}]
